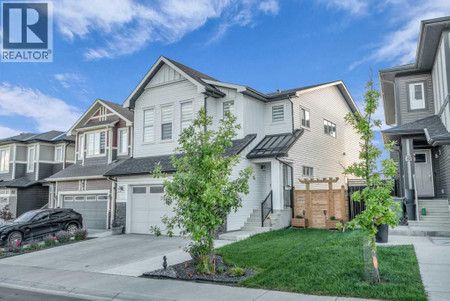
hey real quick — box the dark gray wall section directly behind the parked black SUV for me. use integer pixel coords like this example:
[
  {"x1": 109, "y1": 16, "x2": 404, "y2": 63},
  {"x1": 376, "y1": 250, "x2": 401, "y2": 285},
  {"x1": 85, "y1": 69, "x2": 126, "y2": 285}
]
[{"x1": 17, "y1": 185, "x2": 48, "y2": 216}]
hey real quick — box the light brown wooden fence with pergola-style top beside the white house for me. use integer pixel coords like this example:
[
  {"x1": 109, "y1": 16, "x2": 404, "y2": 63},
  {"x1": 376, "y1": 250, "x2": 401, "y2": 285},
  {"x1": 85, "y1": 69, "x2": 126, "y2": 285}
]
[{"x1": 294, "y1": 178, "x2": 348, "y2": 229}]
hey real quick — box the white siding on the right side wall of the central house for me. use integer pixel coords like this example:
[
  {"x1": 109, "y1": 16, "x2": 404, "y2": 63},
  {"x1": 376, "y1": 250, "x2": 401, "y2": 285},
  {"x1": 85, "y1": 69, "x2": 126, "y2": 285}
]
[{"x1": 289, "y1": 86, "x2": 359, "y2": 189}]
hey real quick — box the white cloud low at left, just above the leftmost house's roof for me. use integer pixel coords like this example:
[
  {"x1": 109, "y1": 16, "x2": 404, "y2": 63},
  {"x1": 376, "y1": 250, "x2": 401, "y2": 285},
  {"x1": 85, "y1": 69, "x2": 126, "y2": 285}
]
[{"x1": 0, "y1": 83, "x2": 81, "y2": 132}]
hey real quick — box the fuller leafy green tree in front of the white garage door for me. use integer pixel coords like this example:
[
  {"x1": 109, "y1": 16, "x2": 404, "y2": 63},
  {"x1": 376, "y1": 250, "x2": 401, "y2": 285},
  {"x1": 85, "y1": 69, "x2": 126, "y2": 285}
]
[{"x1": 152, "y1": 108, "x2": 253, "y2": 273}]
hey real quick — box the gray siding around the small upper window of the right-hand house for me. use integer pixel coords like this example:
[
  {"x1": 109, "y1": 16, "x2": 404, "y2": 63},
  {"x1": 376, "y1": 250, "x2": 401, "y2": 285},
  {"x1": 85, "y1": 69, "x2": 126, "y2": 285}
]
[{"x1": 395, "y1": 74, "x2": 434, "y2": 125}]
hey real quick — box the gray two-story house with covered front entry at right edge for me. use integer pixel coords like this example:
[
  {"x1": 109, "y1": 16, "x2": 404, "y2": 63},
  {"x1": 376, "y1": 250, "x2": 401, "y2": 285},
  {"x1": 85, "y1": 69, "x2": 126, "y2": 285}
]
[{"x1": 379, "y1": 17, "x2": 450, "y2": 222}]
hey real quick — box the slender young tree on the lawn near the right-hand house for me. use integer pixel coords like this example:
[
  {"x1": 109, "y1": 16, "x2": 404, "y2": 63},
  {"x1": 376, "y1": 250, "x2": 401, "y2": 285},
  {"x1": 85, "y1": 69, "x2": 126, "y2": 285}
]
[{"x1": 345, "y1": 80, "x2": 398, "y2": 281}]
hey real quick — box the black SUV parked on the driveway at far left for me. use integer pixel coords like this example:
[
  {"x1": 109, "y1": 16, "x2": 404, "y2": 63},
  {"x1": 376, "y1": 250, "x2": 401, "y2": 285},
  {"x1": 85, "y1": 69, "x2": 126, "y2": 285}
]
[{"x1": 0, "y1": 208, "x2": 83, "y2": 245}]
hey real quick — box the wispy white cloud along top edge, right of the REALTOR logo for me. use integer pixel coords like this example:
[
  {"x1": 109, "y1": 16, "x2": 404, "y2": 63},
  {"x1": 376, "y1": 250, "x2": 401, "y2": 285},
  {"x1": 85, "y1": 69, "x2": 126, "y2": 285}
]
[{"x1": 54, "y1": 0, "x2": 279, "y2": 60}]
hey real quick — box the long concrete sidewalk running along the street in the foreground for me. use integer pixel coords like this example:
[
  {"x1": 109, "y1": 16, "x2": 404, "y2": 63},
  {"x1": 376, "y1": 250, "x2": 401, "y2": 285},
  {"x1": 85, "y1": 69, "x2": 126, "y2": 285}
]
[{"x1": 0, "y1": 262, "x2": 372, "y2": 301}]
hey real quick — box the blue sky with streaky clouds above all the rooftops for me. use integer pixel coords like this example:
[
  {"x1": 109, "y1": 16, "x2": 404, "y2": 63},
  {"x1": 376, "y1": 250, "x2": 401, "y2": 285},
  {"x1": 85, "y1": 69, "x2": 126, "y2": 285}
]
[{"x1": 0, "y1": 0, "x2": 450, "y2": 150}]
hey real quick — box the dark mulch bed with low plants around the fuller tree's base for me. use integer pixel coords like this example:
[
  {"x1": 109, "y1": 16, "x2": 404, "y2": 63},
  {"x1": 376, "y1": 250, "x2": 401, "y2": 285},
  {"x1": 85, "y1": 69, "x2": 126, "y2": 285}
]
[{"x1": 141, "y1": 256, "x2": 256, "y2": 286}]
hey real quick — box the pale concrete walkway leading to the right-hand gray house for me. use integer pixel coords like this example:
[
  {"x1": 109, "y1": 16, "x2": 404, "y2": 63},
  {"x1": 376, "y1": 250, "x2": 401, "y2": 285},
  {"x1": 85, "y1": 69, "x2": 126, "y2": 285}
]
[{"x1": 378, "y1": 235, "x2": 450, "y2": 301}]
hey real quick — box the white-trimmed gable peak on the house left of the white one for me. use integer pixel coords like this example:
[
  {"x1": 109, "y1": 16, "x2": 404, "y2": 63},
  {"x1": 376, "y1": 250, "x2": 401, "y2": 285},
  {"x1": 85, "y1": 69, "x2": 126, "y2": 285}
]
[{"x1": 67, "y1": 98, "x2": 134, "y2": 135}]
